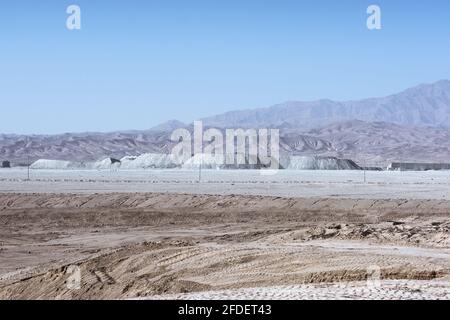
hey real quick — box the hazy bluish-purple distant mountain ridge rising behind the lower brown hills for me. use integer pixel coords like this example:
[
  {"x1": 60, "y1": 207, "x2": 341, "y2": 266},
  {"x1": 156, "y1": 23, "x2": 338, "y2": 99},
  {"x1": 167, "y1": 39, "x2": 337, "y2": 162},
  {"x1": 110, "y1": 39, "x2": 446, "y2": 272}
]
[{"x1": 202, "y1": 80, "x2": 450, "y2": 129}]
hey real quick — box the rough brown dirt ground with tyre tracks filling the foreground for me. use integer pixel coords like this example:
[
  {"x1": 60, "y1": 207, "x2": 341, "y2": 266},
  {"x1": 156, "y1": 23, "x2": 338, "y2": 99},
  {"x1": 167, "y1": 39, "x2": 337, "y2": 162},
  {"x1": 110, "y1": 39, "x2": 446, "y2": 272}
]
[{"x1": 0, "y1": 193, "x2": 450, "y2": 299}]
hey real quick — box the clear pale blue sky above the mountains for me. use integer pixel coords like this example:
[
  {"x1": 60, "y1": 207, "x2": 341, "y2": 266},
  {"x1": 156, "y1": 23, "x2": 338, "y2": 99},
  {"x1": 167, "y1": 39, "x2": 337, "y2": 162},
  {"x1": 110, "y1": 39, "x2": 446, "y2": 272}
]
[{"x1": 0, "y1": 0, "x2": 450, "y2": 133}]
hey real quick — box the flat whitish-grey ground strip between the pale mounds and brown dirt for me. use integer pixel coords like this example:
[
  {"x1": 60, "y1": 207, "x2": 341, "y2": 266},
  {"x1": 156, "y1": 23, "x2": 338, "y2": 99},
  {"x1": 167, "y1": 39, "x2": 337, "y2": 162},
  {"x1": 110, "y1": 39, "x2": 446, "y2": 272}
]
[{"x1": 0, "y1": 168, "x2": 450, "y2": 200}]
